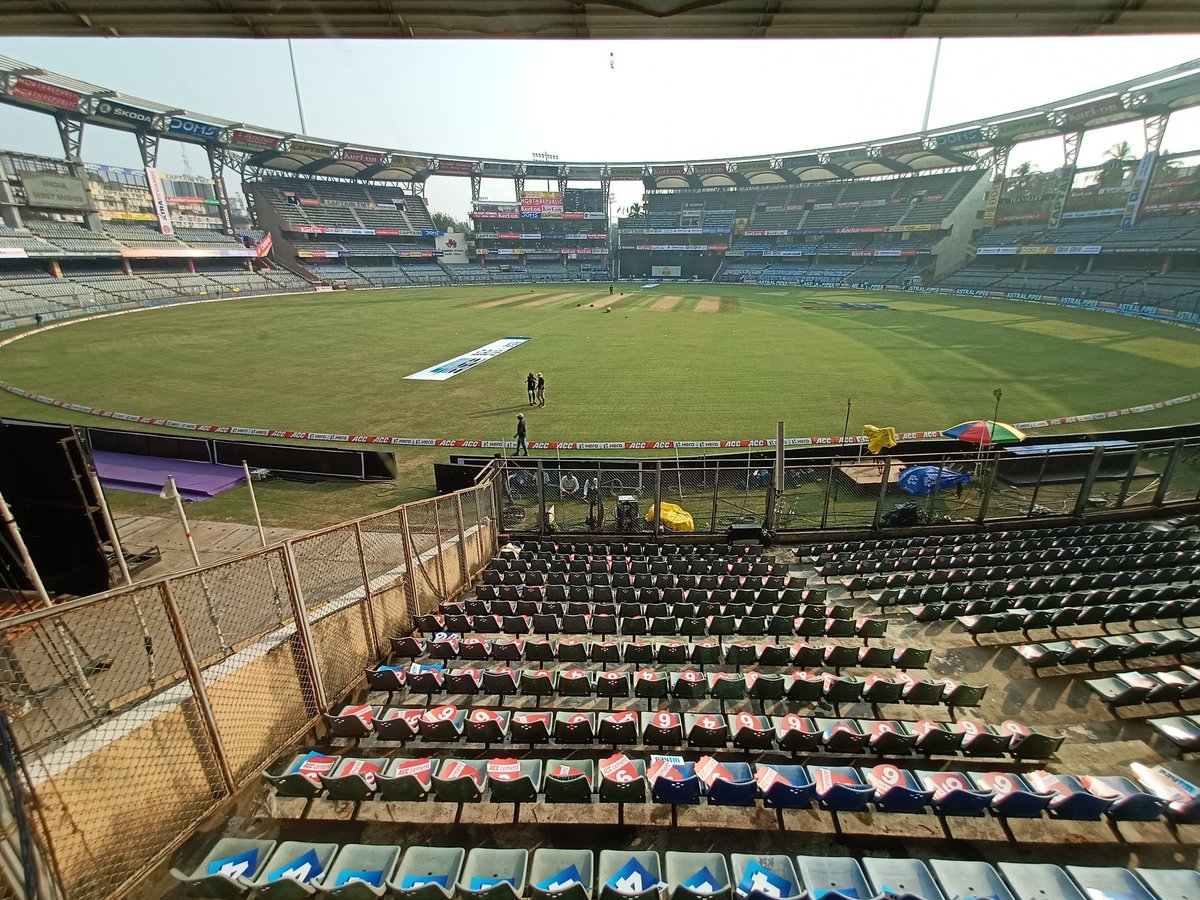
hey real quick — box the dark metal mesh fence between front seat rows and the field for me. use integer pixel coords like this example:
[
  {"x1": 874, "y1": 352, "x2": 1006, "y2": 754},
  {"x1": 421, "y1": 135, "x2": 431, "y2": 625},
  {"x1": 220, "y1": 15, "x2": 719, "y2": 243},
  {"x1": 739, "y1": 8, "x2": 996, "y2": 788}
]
[{"x1": 497, "y1": 439, "x2": 1200, "y2": 538}]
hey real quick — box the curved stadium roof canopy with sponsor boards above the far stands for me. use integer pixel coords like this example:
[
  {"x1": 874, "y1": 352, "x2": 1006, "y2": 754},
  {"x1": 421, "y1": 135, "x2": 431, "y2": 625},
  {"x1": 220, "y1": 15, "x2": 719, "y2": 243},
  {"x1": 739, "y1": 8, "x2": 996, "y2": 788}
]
[{"x1": 0, "y1": 52, "x2": 1200, "y2": 190}]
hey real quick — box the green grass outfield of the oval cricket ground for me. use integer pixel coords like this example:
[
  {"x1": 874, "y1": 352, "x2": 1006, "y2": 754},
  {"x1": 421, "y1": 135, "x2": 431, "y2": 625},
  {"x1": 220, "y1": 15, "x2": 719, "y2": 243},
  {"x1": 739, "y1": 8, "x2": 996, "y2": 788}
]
[{"x1": 0, "y1": 284, "x2": 1200, "y2": 528}]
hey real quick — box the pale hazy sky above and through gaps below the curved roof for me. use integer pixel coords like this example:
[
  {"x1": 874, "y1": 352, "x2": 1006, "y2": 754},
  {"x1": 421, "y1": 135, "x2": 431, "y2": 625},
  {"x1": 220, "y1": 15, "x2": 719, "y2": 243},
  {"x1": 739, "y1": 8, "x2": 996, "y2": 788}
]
[{"x1": 0, "y1": 35, "x2": 1200, "y2": 217}]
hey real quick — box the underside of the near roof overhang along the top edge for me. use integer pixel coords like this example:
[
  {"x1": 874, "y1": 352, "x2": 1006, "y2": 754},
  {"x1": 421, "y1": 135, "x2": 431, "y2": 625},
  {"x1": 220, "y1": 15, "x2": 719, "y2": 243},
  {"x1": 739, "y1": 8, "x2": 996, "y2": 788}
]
[{"x1": 7, "y1": 0, "x2": 1200, "y2": 38}]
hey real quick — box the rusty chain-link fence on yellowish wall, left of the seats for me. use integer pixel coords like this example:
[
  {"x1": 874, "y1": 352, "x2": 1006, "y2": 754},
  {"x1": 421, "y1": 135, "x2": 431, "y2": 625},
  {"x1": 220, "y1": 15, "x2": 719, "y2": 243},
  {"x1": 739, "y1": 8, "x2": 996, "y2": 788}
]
[{"x1": 0, "y1": 475, "x2": 499, "y2": 900}]
